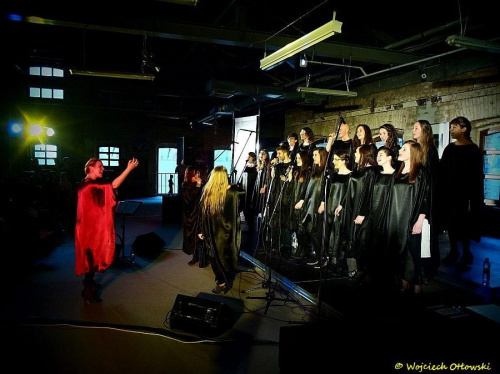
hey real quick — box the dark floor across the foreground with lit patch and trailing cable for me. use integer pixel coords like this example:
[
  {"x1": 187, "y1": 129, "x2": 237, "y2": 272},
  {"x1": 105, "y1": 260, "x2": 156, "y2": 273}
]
[{"x1": 0, "y1": 197, "x2": 500, "y2": 374}]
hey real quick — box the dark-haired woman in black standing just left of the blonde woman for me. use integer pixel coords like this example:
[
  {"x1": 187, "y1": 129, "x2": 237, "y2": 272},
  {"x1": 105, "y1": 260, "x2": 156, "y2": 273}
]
[{"x1": 181, "y1": 166, "x2": 204, "y2": 267}]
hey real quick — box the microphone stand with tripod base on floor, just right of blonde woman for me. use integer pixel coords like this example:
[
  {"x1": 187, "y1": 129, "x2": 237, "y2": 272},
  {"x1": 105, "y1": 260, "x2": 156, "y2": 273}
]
[{"x1": 244, "y1": 165, "x2": 288, "y2": 314}]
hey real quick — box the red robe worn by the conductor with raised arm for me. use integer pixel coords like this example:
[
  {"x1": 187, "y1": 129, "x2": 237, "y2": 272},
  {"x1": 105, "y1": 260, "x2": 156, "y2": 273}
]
[{"x1": 75, "y1": 179, "x2": 116, "y2": 277}]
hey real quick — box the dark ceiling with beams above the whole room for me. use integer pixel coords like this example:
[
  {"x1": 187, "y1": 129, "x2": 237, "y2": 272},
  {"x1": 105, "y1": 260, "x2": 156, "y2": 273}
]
[{"x1": 1, "y1": 0, "x2": 500, "y2": 122}]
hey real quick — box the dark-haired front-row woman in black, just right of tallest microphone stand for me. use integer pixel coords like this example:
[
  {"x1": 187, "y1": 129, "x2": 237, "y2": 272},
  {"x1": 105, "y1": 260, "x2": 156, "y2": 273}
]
[{"x1": 317, "y1": 149, "x2": 352, "y2": 275}]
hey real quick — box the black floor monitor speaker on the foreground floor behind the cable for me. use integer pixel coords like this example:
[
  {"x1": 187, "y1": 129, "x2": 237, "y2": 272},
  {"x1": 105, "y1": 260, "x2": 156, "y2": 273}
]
[{"x1": 167, "y1": 294, "x2": 235, "y2": 336}]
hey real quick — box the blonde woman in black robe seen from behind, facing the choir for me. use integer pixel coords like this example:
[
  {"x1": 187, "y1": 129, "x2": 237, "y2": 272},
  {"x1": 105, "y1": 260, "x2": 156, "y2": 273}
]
[{"x1": 198, "y1": 166, "x2": 245, "y2": 294}]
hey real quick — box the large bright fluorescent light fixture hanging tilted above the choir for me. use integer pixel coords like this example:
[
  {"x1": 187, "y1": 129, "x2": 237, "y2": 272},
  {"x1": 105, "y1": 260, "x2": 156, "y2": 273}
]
[{"x1": 260, "y1": 13, "x2": 342, "y2": 70}]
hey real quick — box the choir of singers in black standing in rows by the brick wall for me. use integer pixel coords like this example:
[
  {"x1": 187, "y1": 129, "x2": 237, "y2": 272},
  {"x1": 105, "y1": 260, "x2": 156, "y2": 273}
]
[{"x1": 242, "y1": 117, "x2": 482, "y2": 295}]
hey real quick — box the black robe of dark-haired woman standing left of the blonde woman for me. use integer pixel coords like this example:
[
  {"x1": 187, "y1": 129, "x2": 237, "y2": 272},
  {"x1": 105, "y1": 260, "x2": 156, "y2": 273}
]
[{"x1": 181, "y1": 182, "x2": 202, "y2": 255}]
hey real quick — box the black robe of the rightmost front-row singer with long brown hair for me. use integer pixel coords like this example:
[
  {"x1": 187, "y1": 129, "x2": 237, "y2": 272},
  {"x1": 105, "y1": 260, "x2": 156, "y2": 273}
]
[{"x1": 387, "y1": 167, "x2": 429, "y2": 284}]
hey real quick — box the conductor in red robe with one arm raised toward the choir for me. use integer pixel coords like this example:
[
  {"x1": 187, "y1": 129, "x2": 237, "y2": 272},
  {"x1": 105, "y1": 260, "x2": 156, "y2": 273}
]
[{"x1": 75, "y1": 158, "x2": 139, "y2": 303}]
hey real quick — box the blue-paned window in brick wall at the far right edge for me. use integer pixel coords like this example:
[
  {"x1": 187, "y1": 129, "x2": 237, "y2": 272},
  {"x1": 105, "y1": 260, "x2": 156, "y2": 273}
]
[{"x1": 480, "y1": 127, "x2": 500, "y2": 205}]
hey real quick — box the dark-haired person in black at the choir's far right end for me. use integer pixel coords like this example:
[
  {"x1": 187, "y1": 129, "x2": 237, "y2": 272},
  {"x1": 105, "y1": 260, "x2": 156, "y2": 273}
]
[{"x1": 439, "y1": 117, "x2": 484, "y2": 270}]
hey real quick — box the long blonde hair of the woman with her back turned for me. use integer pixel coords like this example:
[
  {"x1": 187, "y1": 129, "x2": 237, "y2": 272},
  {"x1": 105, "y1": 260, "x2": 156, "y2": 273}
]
[{"x1": 200, "y1": 165, "x2": 229, "y2": 216}]
